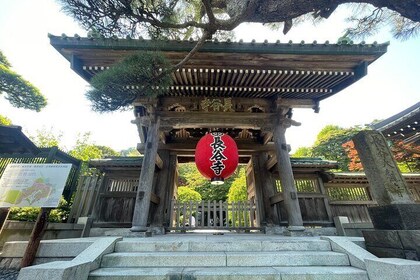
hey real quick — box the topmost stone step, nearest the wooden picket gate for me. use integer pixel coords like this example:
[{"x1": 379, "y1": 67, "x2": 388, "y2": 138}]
[{"x1": 115, "y1": 239, "x2": 331, "y2": 252}]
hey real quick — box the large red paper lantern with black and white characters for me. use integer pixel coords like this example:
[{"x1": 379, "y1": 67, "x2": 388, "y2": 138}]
[{"x1": 195, "y1": 132, "x2": 239, "y2": 185}]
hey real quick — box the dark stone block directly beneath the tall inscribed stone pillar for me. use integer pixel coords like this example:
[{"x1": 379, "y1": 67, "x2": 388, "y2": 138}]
[{"x1": 368, "y1": 204, "x2": 420, "y2": 230}]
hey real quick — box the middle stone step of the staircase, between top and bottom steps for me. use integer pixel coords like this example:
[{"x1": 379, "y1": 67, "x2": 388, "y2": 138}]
[{"x1": 101, "y1": 251, "x2": 349, "y2": 267}]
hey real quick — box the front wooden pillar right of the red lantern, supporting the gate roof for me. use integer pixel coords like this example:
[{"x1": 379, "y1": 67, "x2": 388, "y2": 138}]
[{"x1": 274, "y1": 117, "x2": 305, "y2": 231}]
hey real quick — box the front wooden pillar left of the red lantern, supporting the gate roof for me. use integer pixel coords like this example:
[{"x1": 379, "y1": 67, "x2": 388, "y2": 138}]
[{"x1": 130, "y1": 115, "x2": 160, "y2": 231}]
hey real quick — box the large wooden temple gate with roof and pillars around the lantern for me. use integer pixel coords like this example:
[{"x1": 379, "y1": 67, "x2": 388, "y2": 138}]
[{"x1": 50, "y1": 35, "x2": 388, "y2": 232}]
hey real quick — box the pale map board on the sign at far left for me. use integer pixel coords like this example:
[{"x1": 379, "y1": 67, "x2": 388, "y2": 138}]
[{"x1": 0, "y1": 164, "x2": 71, "y2": 208}]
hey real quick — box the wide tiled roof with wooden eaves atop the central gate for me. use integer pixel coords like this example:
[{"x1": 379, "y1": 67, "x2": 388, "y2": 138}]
[{"x1": 50, "y1": 35, "x2": 388, "y2": 101}]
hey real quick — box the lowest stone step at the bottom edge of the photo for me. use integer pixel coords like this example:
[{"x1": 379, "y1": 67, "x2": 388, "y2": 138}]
[{"x1": 88, "y1": 266, "x2": 369, "y2": 280}]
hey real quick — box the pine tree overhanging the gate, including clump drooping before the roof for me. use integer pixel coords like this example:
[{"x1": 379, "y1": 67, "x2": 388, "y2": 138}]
[{"x1": 59, "y1": 0, "x2": 420, "y2": 112}]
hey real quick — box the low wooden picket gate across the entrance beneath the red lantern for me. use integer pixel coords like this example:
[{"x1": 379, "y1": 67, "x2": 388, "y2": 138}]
[{"x1": 170, "y1": 200, "x2": 260, "y2": 230}]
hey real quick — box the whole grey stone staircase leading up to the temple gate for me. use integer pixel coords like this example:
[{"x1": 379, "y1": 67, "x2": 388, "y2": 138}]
[{"x1": 89, "y1": 234, "x2": 369, "y2": 280}]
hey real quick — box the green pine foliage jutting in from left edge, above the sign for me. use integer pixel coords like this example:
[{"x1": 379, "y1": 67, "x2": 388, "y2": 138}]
[{"x1": 0, "y1": 51, "x2": 47, "y2": 112}]
